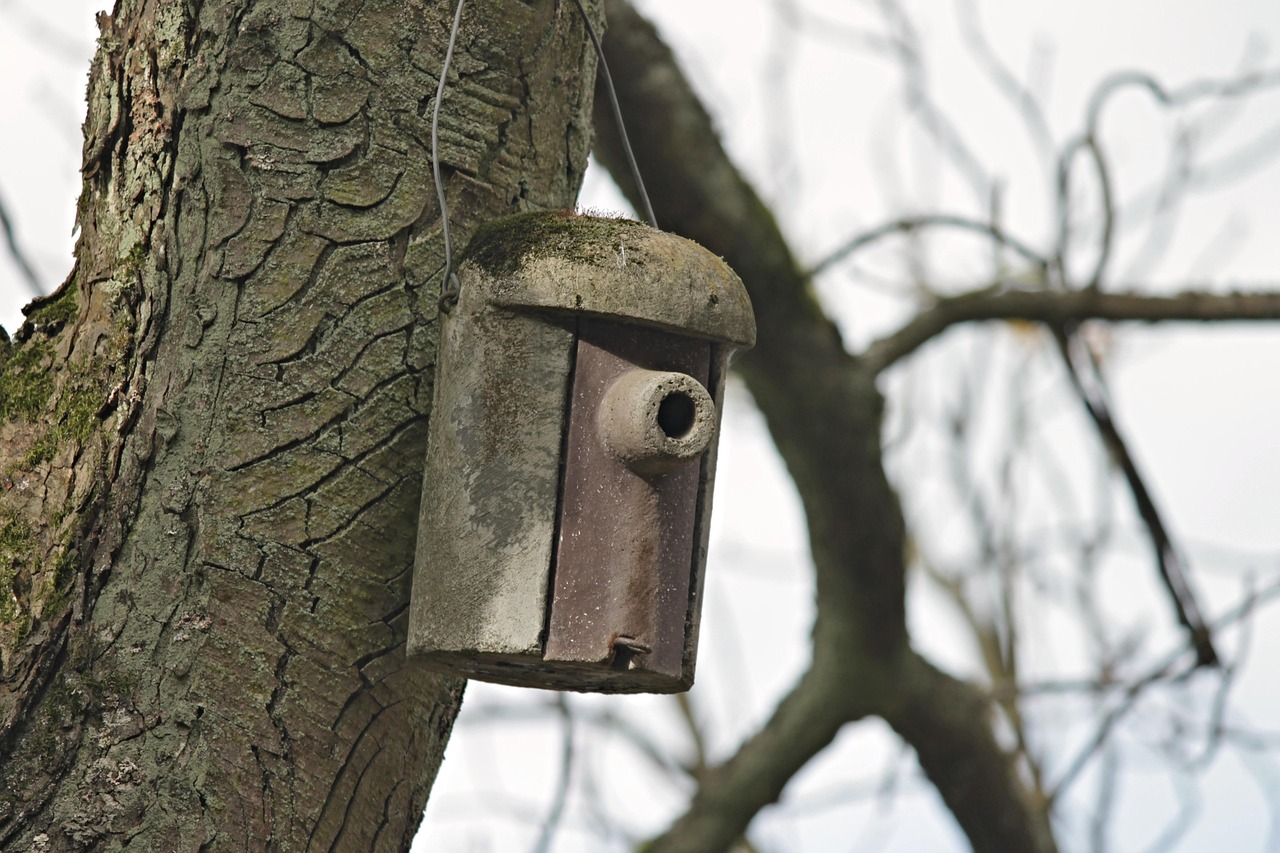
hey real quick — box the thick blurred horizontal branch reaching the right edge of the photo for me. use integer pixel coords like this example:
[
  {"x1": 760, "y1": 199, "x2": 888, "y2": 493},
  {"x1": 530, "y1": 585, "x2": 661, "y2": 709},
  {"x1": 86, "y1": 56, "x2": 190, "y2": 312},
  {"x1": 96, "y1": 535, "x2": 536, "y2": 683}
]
[{"x1": 863, "y1": 284, "x2": 1280, "y2": 373}]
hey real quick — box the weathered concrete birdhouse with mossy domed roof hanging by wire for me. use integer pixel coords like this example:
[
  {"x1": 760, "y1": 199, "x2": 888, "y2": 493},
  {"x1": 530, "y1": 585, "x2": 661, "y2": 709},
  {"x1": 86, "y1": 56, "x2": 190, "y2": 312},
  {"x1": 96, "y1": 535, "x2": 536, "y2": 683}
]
[{"x1": 408, "y1": 213, "x2": 755, "y2": 693}]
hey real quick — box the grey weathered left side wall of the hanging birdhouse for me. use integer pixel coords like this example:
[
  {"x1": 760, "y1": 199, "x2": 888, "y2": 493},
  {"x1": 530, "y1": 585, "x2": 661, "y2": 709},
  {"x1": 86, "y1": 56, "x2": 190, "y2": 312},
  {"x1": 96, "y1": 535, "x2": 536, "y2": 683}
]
[{"x1": 410, "y1": 279, "x2": 573, "y2": 656}]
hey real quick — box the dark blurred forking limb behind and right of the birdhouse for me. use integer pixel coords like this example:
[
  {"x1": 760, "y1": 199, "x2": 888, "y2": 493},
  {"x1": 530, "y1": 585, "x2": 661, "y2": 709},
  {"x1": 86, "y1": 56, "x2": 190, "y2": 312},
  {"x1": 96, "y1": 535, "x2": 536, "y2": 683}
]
[{"x1": 596, "y1": 0, "x2": 1055, "y2": 853}]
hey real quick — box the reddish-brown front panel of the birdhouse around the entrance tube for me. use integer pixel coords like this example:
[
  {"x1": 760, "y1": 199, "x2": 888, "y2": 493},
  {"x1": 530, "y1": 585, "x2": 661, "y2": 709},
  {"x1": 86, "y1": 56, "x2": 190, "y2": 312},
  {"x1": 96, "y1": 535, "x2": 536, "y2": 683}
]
[{"x1": 544, "y1": 319, "x2": 718, "y2": 683}]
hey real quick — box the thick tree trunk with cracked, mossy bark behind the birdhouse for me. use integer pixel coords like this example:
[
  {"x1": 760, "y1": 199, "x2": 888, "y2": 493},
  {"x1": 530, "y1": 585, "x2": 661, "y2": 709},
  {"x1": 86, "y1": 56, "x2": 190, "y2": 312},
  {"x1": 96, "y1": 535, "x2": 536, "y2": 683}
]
[{"x1": 0, "y1": 0, "x2": 594, "y2": 850}]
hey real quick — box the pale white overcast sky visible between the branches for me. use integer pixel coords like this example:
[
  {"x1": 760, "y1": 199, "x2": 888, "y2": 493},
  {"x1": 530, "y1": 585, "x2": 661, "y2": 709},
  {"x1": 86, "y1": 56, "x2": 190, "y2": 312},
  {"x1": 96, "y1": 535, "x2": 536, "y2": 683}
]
[{"x1": 0, "y1": 0, "x2": 1280, "y2": 853}]
